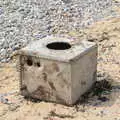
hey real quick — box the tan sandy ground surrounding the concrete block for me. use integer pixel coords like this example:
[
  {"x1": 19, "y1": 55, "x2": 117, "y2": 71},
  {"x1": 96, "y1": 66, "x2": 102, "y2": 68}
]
[{"x1": 0, "y1": 4, "x2": 120, "y2": 120}]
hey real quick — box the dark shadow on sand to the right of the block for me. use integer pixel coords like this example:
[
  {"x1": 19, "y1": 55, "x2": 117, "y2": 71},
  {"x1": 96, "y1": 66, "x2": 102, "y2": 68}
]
[{"x1": 75, "y1": 73, "x2": 120, "y2": 111}]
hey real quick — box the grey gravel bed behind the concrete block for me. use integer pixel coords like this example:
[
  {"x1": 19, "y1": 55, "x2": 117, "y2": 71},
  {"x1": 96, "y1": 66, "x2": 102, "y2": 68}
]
[{"x1": 0, "y1": 0, "x2": 116, "y2": 62}]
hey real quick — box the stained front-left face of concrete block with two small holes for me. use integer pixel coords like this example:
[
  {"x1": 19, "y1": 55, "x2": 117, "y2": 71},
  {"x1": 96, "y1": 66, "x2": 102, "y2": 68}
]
[{"x1": 20, "y1": 56, "x2": 71, "y2": 104}]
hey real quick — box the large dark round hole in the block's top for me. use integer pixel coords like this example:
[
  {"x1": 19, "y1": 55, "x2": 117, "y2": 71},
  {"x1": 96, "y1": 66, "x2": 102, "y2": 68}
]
[{"x1": 47, "y1": 42, "x2": 71, "y2": 50}]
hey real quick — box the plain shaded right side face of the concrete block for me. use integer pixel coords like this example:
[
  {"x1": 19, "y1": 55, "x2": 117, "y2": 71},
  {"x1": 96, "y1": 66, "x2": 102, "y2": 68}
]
[{"x1": 71, "y1": 48, "x2": 97, "y2": 104}]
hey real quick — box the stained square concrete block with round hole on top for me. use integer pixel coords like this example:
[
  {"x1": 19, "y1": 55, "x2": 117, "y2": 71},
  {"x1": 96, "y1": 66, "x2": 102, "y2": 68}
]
[{"x1": 18, "y1": 36, "x2": 97, "y2": 105}]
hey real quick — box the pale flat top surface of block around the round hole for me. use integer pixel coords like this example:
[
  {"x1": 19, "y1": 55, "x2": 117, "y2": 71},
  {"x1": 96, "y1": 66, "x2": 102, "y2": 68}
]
[{"x1": 18, "y1": 36, "x2": 97, "y2": 62}]
